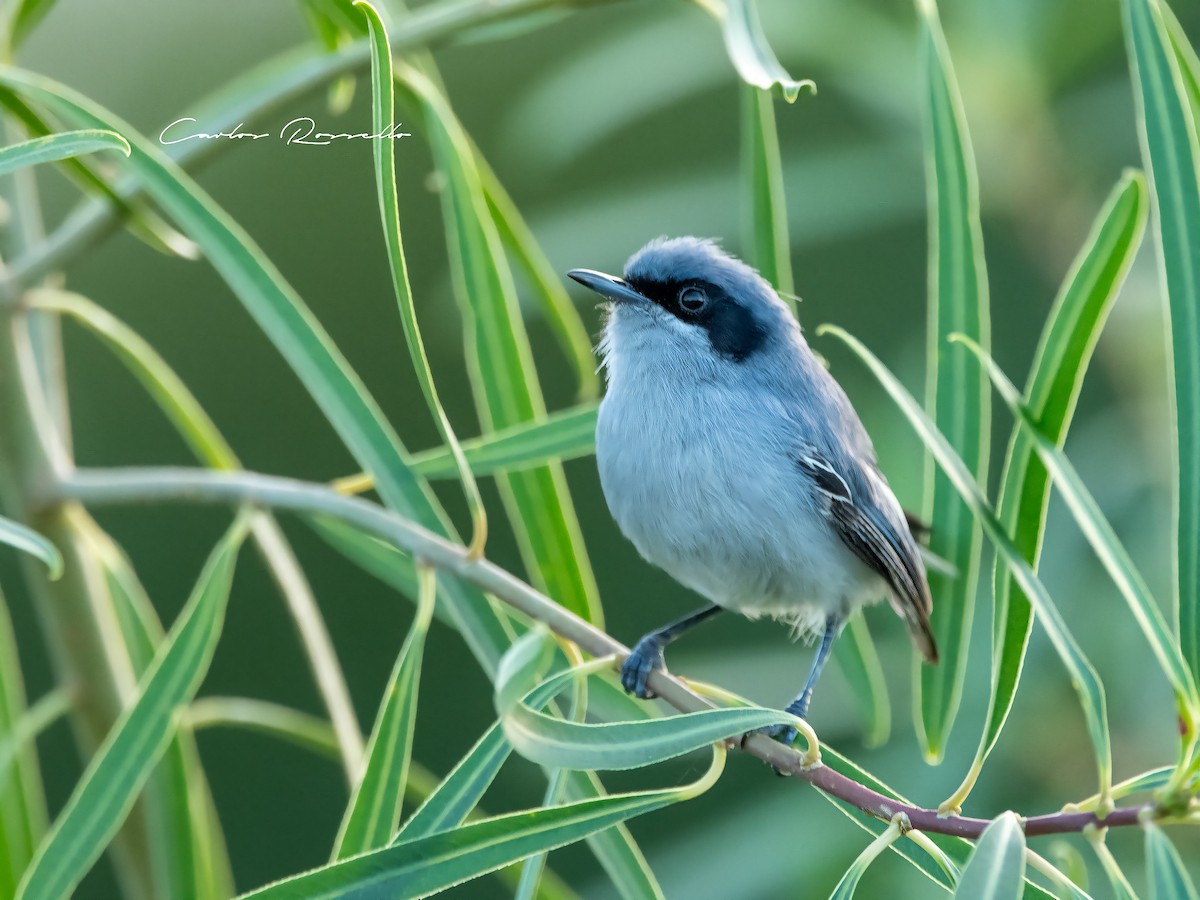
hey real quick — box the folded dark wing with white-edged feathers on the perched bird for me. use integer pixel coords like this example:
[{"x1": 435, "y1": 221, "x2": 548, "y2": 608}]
[{"x1": 797, "y1": 449, "x2": 937, "y2": 662}]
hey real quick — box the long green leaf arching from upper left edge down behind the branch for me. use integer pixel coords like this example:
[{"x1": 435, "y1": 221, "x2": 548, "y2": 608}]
[{"x1": 0, "y1": 68, "x2": 510, "y2": 672}]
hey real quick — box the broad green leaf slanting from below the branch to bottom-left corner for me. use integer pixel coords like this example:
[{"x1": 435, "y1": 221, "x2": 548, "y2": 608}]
[{"x1": 17, "y1": 516, "x2": 246, "y2": 900}]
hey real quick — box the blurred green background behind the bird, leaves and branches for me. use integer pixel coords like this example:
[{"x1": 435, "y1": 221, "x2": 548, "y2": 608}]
[{"x1": 0, "y1": 0, "x2": 1200, "y2": 898}]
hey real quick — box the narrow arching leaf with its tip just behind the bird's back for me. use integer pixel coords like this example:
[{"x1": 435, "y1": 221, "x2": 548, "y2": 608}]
[{"x1": 817, "y1": 325, "x2": 1112, "y2": 798}]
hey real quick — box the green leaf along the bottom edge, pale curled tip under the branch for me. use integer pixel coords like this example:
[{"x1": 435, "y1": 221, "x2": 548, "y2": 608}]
[{"x1": 234, "y1": 748, "x2": 725, "y2": 900}]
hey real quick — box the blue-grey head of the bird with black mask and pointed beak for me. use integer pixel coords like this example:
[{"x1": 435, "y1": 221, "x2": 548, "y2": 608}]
[{"x1": 568, "y1": 238, "x2": 799, "y2": 377}]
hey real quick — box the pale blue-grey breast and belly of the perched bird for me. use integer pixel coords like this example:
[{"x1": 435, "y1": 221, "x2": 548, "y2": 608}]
[{"x1": 596, "y1": 393, "x2": 884, "y2": 631}]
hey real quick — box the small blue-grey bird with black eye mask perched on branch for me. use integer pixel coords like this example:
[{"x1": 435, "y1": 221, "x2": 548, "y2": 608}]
[{"x1": 568, "y1": 236, "x2": 937, "y2": 743}]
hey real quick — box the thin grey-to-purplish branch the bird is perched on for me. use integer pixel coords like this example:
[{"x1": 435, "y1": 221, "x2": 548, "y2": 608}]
[{"x1": 54, "y1": 468, "x2": 1154, "y2": 839}]
